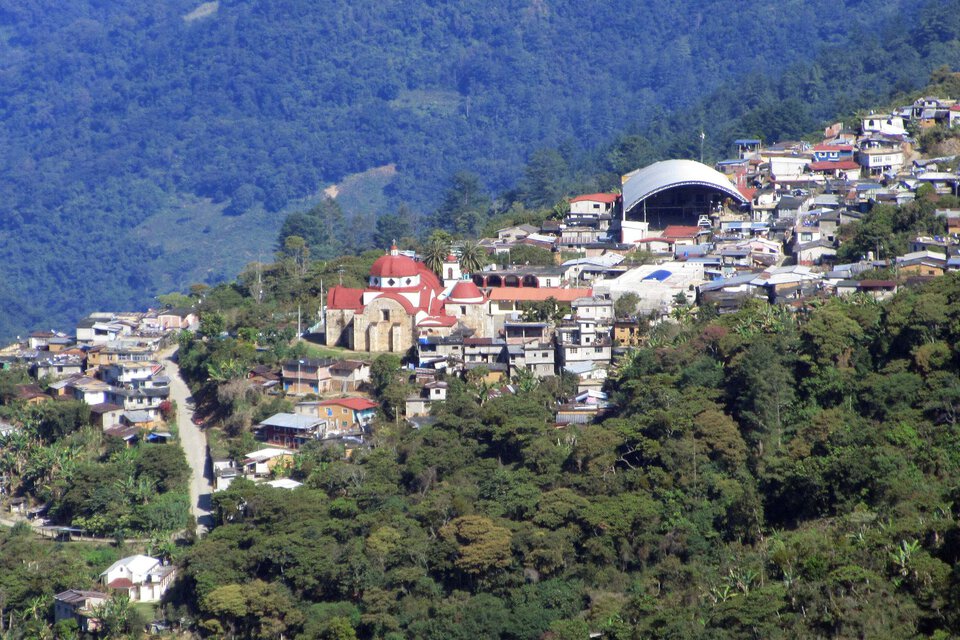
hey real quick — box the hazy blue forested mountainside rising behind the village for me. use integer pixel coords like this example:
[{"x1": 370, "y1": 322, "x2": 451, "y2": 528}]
[{"x1": 0, "y1": 0, "x2": 960, "y2": 337}]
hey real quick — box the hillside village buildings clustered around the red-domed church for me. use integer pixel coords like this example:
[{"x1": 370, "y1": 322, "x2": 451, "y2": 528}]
[{"x1": 0, "y1": 86, "x2": 960, "y2": 631}]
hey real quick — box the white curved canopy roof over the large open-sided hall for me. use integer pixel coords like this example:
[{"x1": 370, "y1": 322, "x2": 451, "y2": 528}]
[{"x1": 623, "y1": 160, "x2": 747, "y2": 212}]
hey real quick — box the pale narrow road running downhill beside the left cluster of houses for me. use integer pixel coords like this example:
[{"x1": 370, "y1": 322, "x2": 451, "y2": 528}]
[{"x1": 163, "y1": 347, "x2": 213, "y2": 535}]
